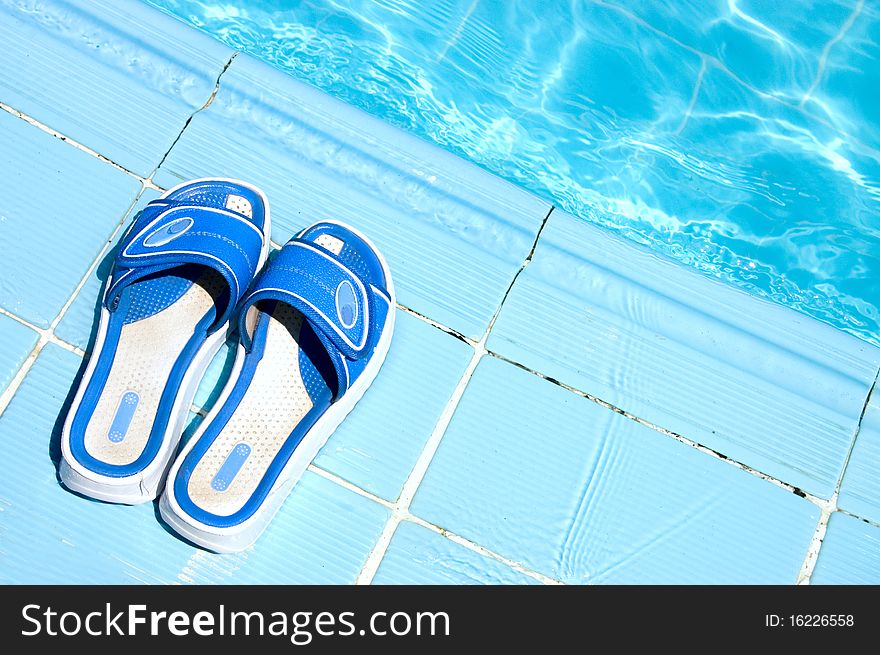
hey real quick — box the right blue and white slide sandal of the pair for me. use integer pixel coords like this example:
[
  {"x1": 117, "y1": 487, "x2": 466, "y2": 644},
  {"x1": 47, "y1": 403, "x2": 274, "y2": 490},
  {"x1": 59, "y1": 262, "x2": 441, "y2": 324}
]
[{"x1": 159, "y1": 221, "x2": 395, "y2": 552}]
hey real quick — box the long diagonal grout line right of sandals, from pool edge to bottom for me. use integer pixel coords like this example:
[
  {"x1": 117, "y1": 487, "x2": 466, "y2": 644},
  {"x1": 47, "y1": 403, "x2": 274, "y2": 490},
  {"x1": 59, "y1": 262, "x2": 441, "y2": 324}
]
[{"x1": 355, "y1": 207, "x2": 553, "y2": 585}]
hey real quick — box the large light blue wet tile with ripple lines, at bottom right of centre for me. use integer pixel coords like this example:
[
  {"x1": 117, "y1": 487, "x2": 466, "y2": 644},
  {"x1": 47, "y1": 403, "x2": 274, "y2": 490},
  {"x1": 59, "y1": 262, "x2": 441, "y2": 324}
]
[{"x1": 411, "y1": 357, "x2": 819, "y2": 583}]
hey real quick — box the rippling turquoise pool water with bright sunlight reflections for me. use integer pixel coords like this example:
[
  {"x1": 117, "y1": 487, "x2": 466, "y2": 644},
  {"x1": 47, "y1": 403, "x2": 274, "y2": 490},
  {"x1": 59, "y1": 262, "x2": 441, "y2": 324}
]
[{"x1": 144, "y1": 0, "x2": 880, "y2": 344}]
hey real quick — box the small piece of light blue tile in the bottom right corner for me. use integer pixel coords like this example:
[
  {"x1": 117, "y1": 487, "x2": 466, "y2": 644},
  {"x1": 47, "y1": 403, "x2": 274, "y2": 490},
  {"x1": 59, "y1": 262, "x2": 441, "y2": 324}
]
[{"x1": 810, "y1": 512, "x2": 880, "y2": 585}]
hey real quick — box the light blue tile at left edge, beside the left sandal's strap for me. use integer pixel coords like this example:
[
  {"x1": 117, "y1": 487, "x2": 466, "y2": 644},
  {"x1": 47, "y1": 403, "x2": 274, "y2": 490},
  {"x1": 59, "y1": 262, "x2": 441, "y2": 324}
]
[{"x1": 0, "y1": 111, "x2": 141, "y2": 334}]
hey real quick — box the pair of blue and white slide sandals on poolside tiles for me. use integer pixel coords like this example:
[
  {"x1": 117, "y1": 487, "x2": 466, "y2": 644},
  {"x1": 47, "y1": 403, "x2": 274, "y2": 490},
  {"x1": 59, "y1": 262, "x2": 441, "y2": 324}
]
[{"x1": 59, "y1": 179, "x2": 395, "y2": 552}]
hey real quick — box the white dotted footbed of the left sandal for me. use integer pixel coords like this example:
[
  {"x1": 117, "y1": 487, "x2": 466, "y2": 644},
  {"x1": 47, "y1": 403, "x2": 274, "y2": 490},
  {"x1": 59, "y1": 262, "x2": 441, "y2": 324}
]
[{"x1": 84, "y1": 270, "x2": 226, "y2": 466}]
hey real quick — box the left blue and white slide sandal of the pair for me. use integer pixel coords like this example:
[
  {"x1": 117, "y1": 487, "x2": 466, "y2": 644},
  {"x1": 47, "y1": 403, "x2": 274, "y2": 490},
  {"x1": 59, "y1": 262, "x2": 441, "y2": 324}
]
[{"x1": 59, "y1": 179, "x2": 269, "y2": 504}]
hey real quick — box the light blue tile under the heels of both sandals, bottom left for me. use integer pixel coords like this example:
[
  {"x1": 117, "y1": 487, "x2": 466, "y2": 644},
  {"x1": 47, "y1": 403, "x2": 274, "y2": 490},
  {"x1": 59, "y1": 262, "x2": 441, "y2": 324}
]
[{"x1": 0, "y1": 344, "x2": 387, "y2": 584}]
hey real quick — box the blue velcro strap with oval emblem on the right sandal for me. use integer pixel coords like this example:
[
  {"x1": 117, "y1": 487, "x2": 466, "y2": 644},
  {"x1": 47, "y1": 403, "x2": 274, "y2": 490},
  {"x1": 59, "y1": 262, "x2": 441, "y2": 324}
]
[{"x1": 239, "y1": 239, "x2": 373, "y2": 360}]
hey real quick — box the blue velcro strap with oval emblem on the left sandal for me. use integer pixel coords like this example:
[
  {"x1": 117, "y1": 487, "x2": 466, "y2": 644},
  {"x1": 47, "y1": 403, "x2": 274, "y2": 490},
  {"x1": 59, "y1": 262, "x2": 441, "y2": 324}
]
[{"x1": 108, "y1": 203, "x2": 263, "y2": 306}]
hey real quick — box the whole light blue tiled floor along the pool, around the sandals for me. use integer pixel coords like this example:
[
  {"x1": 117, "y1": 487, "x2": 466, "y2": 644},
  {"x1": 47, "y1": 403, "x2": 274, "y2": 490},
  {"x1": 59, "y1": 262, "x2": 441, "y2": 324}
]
[{"x1": 0, "y1": 0, "x2": 880, "y2": 584}]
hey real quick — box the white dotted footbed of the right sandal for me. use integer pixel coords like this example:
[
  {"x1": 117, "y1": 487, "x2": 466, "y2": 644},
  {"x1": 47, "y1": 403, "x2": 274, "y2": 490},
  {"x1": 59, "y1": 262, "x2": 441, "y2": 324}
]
[{"x1": 187, "y1": 303, "x2": 313, "y2": 516}]
